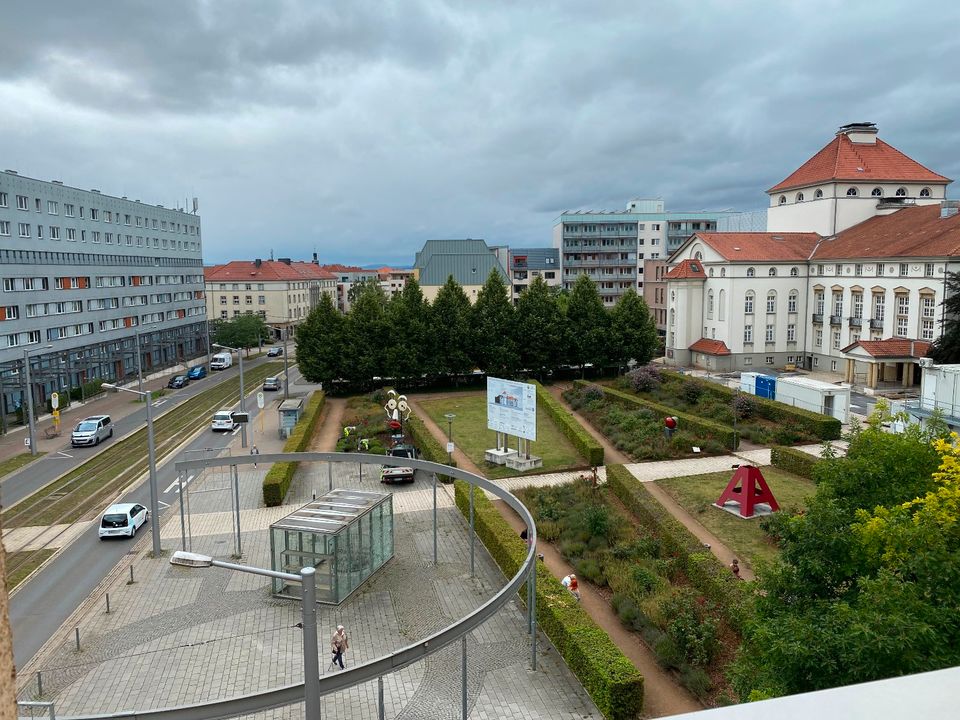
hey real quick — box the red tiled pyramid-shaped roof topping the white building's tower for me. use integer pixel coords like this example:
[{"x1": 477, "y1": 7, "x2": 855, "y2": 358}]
[{"x1": 767, "y1": 133, "x2": 950, "y2": 193}]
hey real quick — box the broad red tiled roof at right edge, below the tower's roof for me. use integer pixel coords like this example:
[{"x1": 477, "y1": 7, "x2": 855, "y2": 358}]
[{"x1": 813, "y1": 204, "x2": 960, "y2": 260}]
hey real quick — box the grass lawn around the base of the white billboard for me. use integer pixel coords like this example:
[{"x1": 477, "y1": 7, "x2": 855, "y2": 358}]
[{"x1": 417, "y1": 393, "x2": 587, "y2": 478}]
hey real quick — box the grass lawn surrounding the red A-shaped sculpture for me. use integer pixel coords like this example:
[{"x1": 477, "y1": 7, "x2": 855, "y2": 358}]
[{"x1": 657, "y1": 466, "x2": 816, "y2": 567}]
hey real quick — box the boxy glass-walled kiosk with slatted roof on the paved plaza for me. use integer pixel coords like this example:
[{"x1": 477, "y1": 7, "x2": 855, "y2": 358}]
[{"x1": 270, "y1": 488, "x2": 393, "y2": 605}]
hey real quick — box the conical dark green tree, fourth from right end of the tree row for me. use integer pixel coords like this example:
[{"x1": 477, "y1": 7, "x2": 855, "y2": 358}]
[{"x1": 470, "y1": 270, "x2": 518, "y2": 378}]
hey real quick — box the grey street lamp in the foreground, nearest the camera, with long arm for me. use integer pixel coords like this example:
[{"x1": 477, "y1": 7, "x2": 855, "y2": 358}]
[{"x1": 170, "y1": 550, "x2": 320, "y2": 720}]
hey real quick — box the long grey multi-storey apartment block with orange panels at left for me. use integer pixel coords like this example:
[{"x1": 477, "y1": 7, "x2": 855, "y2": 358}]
[{"x1": 0, "y1": 170, "x2": 206, "y2": 413}]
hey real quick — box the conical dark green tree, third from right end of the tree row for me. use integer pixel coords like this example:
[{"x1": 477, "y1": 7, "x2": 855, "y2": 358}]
[{"x1": 513, "y1": 277, "x2": 567, "y2": 380}]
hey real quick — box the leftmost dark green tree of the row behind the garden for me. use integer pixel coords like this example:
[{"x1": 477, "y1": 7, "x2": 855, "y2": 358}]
[{"x1": 296, "y1": 293, "x2": 347, "y2": 387}]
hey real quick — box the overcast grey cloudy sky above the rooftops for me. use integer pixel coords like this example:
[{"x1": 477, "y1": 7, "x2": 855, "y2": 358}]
[{"x1": 0, "y1": 0, "x2": 960, "y2": 265}]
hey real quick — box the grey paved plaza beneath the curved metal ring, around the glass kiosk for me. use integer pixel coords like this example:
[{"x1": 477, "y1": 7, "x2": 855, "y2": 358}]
[{"x1": 19, "y1": 463, "x2": 600, "y2": 719}]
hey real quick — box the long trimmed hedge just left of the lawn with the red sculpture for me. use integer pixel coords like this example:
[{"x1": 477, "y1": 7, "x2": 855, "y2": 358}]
[{"x1": 607, "y1": 465, "x2": 750, "y2": 632}]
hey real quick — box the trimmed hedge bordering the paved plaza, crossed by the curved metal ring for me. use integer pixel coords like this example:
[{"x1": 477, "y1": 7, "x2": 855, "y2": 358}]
[{"x1": 455, "y1": 480, "x2": 643, "y2": 720}]
